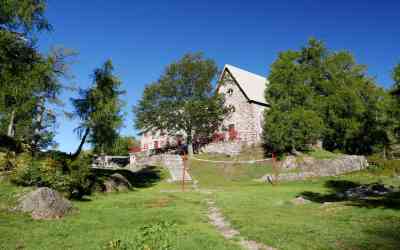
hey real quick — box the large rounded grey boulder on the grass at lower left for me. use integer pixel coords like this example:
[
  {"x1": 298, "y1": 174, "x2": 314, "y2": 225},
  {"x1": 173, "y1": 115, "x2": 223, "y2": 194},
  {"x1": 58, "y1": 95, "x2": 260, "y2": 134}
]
[{"x1": 14, "y1": 187, "x2": 72, "y2": 219}]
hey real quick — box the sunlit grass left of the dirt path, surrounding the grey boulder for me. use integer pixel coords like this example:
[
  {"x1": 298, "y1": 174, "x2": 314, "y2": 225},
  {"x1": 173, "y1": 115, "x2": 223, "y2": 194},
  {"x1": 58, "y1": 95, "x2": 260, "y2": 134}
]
[{"x1": 0, "y1": 166, "x2": 239, "y2": 249}]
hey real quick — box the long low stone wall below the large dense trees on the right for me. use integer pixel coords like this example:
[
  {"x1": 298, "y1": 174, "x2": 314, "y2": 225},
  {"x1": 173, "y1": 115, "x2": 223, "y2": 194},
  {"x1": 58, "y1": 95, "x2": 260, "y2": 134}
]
[{"x1": 261, "y1": 155, "x2": 368, "y2": 181}]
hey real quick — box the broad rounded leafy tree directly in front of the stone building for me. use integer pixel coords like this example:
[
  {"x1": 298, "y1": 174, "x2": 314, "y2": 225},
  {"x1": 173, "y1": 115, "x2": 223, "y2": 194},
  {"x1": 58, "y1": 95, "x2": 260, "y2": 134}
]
[{"x1": 133, "y1": 53, "x2": 229, "y2": 154}]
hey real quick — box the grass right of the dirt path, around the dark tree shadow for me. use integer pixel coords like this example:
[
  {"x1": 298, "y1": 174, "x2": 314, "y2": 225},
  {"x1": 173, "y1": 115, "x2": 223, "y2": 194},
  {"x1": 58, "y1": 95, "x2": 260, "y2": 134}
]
[{"x1": 191, "y1": 153, "x2": 400, "y2": 249}]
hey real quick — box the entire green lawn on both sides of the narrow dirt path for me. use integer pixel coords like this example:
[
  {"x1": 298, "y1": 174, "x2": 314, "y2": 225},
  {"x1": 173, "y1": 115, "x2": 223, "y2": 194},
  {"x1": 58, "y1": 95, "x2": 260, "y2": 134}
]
[{"x1": 0, "y1": 155, "x2": 400, "y2": 250}]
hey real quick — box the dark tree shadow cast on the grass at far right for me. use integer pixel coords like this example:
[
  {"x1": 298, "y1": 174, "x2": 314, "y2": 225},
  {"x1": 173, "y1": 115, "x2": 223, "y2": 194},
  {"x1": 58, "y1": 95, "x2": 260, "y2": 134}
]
[{"x1": 300, "y1": 180, "x2": 400, "y2": 209}]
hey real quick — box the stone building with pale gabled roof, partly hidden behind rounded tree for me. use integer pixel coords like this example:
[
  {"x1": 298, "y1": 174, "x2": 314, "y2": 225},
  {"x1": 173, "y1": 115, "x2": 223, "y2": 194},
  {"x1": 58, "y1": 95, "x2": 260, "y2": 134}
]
[{"x1": 141, "y1": 64, "x2": 268, "y2": 151}]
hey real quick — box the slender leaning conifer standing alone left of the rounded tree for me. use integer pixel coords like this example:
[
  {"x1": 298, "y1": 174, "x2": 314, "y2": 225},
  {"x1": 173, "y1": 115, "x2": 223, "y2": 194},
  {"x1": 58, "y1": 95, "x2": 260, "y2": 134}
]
[{"x1": 72, "y1": 60, "x2": 124, "y2": 154}]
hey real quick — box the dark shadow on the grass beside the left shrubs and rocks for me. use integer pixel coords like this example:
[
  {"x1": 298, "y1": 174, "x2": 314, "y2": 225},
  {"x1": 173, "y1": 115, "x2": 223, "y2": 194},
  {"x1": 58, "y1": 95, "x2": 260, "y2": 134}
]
[{"x1": 94, "y1": 166, "x2": 162, "y2": 188}]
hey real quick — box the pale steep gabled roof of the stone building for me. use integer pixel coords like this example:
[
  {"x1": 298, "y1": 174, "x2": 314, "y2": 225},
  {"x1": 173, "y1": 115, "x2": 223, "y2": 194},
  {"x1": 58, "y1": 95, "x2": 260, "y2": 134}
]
[{"x1": 219, "y1": 64, "x2": 268, "y2": 105}]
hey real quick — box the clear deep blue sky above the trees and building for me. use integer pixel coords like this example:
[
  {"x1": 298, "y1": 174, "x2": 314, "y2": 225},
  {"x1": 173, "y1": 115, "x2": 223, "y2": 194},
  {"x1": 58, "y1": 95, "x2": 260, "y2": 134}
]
[{"x1": 39, "y1": 0, "x2": 400, "y2": 152}]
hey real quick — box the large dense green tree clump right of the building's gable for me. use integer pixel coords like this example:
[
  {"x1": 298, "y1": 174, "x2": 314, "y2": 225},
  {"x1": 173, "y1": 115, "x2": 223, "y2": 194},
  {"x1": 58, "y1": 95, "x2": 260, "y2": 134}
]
[{"x1": 264, "y1": 39, "x2": 393, "y2": 154}]
